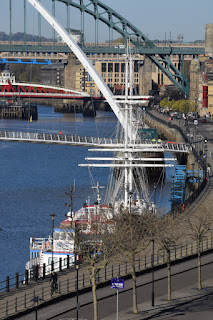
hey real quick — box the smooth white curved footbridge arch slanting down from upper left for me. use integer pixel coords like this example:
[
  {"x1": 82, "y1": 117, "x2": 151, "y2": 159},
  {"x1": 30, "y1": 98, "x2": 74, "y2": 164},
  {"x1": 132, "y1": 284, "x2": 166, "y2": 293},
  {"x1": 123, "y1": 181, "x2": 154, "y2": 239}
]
[{"x1": 28, "y1": 0, "x2": 136, "y2": 138}]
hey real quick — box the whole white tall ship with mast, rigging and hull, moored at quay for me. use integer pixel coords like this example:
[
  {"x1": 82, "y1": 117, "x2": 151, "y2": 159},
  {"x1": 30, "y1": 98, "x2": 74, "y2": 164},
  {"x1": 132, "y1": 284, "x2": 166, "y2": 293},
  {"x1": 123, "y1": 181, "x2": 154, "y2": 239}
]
[{"x1": 26, "y1": 42, "x2": 186, "y2": 276}]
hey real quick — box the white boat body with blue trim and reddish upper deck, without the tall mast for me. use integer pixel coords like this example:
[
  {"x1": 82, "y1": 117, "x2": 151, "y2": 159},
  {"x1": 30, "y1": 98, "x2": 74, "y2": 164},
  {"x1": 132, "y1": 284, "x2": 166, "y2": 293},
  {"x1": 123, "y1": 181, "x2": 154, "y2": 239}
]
[{"x1": 25, "y1": 198, "x2": 111, "y2": 277}]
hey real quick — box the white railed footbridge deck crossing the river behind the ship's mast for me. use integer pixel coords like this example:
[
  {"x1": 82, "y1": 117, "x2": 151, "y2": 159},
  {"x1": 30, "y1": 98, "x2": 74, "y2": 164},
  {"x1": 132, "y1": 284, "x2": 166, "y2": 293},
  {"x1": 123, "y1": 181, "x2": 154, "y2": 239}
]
[{"x1": 0, "y1": 131, "x2": 189, "y2": 153}]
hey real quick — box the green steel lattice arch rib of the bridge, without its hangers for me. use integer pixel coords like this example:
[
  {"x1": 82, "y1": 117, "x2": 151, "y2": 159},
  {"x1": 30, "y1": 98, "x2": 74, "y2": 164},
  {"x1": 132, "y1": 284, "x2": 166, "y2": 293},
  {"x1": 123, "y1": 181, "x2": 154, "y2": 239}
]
[{"x1": 57, "y1": 0, "x2": 189, "y2": 97}]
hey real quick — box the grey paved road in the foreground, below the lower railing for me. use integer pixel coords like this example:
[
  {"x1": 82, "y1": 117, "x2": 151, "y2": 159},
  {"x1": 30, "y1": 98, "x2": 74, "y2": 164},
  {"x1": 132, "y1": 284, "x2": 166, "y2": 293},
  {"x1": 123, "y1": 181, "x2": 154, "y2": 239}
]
[{"x1": 16, "y1": 253, "x2": 213, "y2": 320}]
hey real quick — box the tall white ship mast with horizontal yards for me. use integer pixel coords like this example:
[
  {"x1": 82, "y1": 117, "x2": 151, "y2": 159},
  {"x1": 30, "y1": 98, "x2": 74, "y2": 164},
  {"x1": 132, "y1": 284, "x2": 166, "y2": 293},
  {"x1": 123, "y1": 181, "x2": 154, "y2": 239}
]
[{"x1": 79, "y1": 40, "x2": 172, "y2": 208}]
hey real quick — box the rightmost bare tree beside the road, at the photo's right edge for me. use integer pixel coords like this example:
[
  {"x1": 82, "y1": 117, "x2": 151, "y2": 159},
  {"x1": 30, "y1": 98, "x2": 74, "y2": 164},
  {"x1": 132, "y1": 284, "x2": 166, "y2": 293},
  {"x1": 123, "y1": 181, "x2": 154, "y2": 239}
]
[{"x1": 183, "y1": 207, "x2": 213, "y2": 290}]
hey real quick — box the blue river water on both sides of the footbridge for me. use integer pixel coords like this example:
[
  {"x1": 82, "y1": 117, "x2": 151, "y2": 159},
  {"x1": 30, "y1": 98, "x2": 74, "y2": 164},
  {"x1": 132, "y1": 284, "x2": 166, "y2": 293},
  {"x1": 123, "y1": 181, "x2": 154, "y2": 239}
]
[{"x1": 0, "y1": 106, "x2": 174, "y2": 281}]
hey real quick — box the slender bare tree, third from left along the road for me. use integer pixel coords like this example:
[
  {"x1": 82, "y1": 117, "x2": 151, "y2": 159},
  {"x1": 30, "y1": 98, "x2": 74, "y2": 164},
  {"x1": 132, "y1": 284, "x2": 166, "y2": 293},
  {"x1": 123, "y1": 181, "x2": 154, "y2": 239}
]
[{"x1": 156, "y1": 214, "x2": 182, "y2": 300}]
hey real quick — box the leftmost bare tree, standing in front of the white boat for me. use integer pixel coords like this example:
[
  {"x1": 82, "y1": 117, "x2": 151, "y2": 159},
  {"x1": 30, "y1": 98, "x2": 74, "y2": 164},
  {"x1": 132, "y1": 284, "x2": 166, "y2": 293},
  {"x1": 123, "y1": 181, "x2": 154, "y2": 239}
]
[{"x1": 75, "y1": 206, "x2": 117, "y2": 320}]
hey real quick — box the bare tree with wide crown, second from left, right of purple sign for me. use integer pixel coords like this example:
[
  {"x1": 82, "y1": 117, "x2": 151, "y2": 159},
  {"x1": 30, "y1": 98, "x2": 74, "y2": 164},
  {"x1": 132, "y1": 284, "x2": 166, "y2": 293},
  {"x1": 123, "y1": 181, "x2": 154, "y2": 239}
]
[{"x1": 115, "y1": 210, "x2": 153, "y2": 313}]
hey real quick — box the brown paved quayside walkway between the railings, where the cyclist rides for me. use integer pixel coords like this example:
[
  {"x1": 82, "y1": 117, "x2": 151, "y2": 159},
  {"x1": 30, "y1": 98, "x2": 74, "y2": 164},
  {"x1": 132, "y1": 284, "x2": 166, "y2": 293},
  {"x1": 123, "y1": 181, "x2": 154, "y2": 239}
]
[{"x1": 0, "y1": 238, "x2": 213, "y2": 320}]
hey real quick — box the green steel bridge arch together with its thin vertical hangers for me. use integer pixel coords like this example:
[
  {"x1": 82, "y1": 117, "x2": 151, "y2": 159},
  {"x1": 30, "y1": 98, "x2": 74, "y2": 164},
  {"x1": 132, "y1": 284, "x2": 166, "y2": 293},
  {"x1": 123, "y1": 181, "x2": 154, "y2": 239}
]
[{"x1": 5, "y1": 0, "x2": 189, "y2": 96}]
